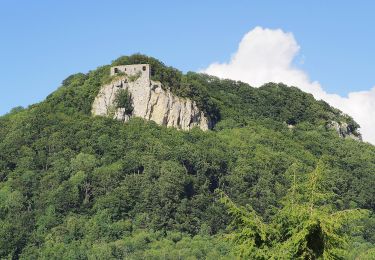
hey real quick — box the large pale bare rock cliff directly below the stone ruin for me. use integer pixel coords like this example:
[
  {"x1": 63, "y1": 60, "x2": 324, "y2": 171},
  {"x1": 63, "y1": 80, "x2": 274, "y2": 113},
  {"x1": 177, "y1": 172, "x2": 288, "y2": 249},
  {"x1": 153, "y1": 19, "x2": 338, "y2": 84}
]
[{"x1": 92, "y1": 75, "x2": 211, "y2": 130}]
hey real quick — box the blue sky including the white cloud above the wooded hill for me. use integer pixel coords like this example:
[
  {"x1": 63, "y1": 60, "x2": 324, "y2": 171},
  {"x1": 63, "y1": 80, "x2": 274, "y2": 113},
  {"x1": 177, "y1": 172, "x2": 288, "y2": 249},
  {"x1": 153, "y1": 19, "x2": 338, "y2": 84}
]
[{"x1": 0, "y1": 0, "x2": 375, "y2": 143}]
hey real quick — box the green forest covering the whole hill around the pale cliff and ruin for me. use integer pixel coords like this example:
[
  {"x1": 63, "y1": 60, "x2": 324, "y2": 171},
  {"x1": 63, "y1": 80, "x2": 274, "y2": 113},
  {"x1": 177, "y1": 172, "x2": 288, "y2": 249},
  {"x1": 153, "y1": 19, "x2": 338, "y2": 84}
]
[{"x1": 0, "y1": 54, "x2": 375, "y2": 259}]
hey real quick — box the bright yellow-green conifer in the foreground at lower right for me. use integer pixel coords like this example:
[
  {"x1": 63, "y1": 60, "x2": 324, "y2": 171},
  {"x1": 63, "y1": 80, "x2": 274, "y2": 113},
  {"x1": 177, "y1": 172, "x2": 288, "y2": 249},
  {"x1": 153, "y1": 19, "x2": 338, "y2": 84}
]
[{"x1": 219, "y1": 162, "x2": 368, "y2": 259}]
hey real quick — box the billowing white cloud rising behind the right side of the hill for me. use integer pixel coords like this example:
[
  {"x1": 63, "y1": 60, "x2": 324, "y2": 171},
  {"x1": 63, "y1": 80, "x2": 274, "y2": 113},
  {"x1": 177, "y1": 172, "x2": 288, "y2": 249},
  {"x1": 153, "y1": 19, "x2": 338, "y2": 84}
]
[{"x1": 202, "y1": 27, "x2": 375, "y2": 144}]
